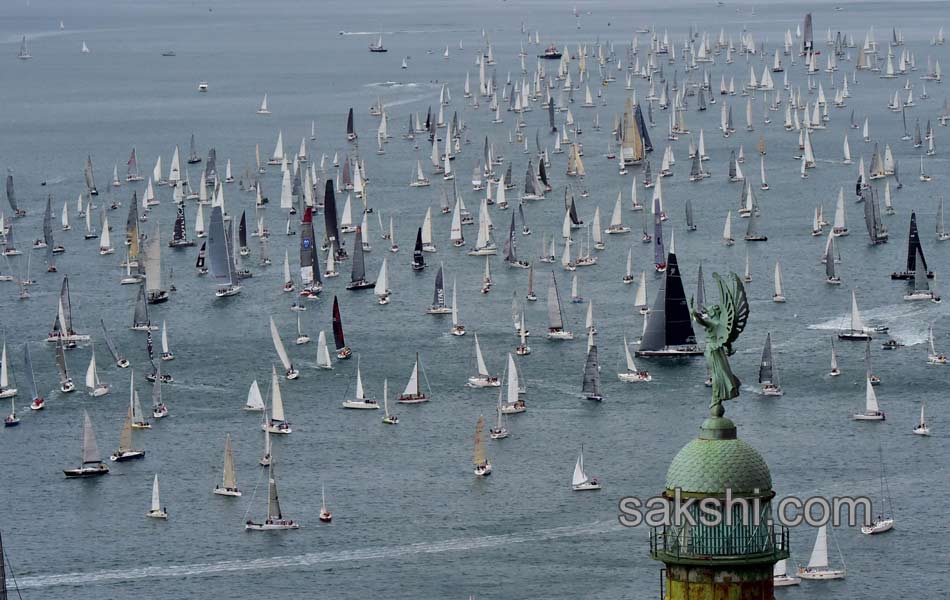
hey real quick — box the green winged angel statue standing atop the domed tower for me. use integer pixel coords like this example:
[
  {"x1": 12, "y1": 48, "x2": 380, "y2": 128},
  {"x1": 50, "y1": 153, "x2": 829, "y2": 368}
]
[{"x1": 691, "y1": 273, "x2": 749, "y2": 417}]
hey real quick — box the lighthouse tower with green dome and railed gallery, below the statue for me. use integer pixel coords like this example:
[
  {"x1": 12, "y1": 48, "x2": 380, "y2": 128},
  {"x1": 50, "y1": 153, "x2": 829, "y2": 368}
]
[{"x1": 650, "y1": 404, "x2": 788, "y2": 600}]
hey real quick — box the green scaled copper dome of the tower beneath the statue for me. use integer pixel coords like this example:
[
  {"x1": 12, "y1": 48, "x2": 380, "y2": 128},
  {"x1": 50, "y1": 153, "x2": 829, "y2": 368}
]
[{"x1": 666, "y1": 416, "x2": 772, "y2": 497}]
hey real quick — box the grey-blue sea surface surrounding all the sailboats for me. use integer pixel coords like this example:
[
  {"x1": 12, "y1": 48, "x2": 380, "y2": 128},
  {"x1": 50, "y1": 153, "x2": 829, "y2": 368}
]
[{"x1": 0, "y1": 0, "x2": 950, "y2": 600}]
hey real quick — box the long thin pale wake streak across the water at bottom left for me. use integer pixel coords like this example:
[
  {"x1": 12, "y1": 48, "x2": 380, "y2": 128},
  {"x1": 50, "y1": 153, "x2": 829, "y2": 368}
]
[{"x1": 17, "y1": 520, "x2": 623, "y2": 589}]
